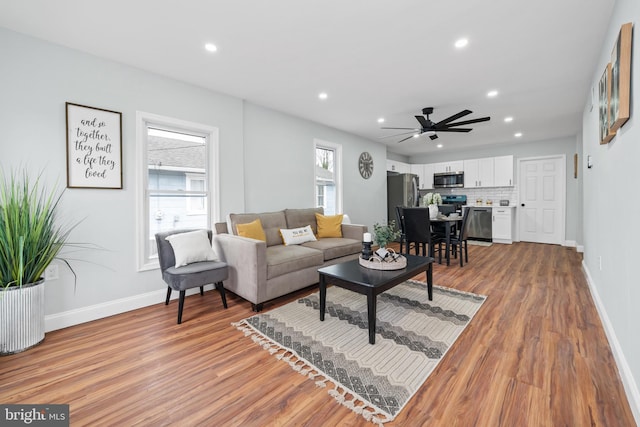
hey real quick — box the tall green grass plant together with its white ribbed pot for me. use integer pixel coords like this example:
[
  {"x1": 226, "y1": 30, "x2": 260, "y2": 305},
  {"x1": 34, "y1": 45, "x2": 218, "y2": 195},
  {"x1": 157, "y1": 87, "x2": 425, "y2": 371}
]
[{"x1": 0, "y1": 170, "x2": 74, "y2": 354}]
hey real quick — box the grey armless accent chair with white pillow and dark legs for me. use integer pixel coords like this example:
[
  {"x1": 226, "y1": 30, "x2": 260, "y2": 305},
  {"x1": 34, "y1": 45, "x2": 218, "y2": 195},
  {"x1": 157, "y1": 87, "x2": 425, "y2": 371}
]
[{"x1": 155, "y1": 229, "x2": 229, "y2": 324}]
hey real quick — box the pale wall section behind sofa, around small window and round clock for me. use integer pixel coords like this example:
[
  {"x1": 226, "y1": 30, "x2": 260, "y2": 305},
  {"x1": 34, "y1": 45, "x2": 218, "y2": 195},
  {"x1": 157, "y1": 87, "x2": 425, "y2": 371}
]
[{"x1": 244, "y1": 103, "x2": 387, "y2": 228}]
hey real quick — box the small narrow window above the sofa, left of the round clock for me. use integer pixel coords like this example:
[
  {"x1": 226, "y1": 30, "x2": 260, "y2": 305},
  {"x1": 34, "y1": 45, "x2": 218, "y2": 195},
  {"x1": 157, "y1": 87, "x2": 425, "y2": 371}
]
[{"x1": 315, "y1": 140, "x2": 342, "y2": 215}]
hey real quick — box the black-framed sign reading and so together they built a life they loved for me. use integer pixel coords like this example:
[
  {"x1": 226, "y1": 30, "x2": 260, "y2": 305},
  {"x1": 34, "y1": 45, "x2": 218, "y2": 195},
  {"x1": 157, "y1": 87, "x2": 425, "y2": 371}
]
[{"x1": 66, "y1": 102, "x2": 122, "y2": 189}]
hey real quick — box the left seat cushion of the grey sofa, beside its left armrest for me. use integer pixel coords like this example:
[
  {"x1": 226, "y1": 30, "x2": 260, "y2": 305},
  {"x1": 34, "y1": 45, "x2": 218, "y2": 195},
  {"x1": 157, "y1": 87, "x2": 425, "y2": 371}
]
[{"x1": 267, "y1": 242, "x2": 324, "y2": 280}]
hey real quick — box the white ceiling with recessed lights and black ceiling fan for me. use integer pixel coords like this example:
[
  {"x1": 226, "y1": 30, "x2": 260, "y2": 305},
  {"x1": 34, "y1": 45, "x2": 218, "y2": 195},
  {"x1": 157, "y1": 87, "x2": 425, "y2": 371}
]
[{"x1": 0, "y1": 0, "x2": 614, "y2": 156}]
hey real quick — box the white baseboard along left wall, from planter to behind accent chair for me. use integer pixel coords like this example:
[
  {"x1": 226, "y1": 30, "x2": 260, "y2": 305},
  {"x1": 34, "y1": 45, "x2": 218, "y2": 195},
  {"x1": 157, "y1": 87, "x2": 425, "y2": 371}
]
[{"x1": 44, "y1": 285, "x2": 215, "y2": 332}]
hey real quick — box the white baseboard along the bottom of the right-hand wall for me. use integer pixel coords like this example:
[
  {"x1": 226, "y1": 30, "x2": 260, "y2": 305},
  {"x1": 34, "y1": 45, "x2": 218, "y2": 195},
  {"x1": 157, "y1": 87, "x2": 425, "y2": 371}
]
[{"x1": 582, "y1": 261, "x2": 640, "y2": 425}]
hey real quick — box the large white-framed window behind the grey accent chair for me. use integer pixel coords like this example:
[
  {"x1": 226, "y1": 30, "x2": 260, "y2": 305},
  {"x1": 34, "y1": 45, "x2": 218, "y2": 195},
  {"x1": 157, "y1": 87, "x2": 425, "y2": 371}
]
[{"x1": 136, "y1": 112, "x2": 219, "y2": 270}]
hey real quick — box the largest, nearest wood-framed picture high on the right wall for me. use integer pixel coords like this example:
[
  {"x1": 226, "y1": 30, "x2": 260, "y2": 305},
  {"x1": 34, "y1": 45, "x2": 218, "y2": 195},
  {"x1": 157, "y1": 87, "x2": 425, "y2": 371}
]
[{"x1": 609, "y1": 22, "x2": 633, "y2": 133}]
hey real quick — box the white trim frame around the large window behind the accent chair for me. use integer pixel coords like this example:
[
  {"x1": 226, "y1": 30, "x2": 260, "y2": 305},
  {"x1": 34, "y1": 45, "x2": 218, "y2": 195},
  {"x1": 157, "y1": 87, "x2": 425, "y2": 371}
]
[{"x1": 134, "y1": 111, "x2": 220, "y2": 271}]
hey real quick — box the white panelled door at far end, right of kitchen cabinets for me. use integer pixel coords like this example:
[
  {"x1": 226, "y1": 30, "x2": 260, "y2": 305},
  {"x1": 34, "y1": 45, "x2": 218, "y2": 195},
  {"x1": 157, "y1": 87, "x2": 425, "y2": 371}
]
[{"x1": 518, "y1": 156, "x2": 566, "y2": 245}]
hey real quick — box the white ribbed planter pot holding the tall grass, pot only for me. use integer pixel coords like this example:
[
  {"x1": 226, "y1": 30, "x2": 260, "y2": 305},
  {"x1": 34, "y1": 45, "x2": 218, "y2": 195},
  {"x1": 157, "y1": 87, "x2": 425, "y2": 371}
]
[{"x1": 0, "y1": 279, "x2": 44, "y2": 355}]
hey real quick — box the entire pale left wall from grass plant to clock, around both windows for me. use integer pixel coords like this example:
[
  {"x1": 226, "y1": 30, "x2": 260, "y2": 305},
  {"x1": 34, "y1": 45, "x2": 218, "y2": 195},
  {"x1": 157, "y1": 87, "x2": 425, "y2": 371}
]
[{"x1": 0, "y1": 28, "x2": 386, "y2": 330}]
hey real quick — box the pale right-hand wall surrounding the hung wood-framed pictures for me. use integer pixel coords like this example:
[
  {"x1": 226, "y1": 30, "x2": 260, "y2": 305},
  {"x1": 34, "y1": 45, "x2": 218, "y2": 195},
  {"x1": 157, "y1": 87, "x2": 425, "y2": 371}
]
[{"x1": 581, "y1": 0, "x2": 640, "y2": 423}]
